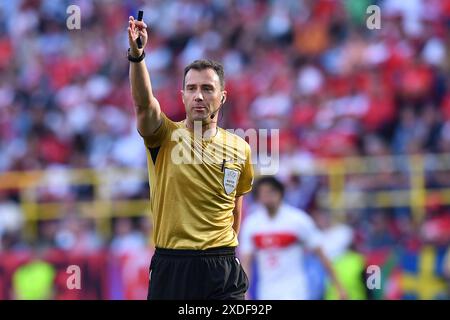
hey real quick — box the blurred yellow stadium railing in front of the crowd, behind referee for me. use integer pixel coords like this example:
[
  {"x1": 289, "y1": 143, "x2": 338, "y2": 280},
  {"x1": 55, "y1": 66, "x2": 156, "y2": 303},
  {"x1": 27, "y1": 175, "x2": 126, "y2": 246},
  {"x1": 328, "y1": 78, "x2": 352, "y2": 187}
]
[{"x1": 0, "y1": 154, "x2": 450, "y2": 239}]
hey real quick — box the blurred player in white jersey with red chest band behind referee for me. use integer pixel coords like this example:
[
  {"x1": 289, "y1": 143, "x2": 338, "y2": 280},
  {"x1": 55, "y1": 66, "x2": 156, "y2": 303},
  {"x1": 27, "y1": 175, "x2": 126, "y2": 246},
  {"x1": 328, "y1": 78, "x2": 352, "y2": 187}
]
[{"x1": 240, "y1": 177, "x2": 346, "y2": 300}]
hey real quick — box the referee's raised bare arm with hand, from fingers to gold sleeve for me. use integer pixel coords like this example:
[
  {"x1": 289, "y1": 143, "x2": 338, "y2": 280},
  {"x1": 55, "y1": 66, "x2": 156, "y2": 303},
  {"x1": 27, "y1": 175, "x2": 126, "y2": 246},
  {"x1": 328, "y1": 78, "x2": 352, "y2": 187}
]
[{"x1": 128, "y1": 16, "x2": 161, "y2": 136}]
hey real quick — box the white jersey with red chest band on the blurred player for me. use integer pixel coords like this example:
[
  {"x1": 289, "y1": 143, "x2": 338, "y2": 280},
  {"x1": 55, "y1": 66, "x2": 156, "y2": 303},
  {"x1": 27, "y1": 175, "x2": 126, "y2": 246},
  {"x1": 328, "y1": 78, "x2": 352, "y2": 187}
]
[{"x1": 240, "y1": 204, "x2": 321, "y2": 300}]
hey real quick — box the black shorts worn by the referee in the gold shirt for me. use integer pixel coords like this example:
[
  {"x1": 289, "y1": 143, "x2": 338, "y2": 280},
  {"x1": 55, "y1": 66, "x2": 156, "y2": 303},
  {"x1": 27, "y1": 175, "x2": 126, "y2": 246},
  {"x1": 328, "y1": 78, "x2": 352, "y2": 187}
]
[{"x1": 147, "y1": 247, "x2": 248, "y2": 300}]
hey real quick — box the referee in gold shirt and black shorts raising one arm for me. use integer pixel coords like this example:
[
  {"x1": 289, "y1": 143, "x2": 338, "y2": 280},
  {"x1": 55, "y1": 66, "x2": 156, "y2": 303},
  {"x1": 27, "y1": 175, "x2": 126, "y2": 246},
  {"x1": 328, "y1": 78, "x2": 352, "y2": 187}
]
[{"x1": 128, "y1": 17, "x2": 253, "y2": 300}]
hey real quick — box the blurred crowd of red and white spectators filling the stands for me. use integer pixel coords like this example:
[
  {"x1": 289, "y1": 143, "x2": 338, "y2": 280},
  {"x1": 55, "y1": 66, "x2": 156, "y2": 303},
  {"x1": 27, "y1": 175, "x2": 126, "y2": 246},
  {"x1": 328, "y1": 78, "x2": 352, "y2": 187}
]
[{"x1": 0, "y1": 0, "x2": 450, "y2": 300}]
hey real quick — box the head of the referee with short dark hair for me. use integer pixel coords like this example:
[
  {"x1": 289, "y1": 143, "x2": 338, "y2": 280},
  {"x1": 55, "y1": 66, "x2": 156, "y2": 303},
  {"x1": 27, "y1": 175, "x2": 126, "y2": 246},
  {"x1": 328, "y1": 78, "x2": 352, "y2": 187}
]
[{"x1": 181, "y1": 69, "x2": 226, "y2": 123}]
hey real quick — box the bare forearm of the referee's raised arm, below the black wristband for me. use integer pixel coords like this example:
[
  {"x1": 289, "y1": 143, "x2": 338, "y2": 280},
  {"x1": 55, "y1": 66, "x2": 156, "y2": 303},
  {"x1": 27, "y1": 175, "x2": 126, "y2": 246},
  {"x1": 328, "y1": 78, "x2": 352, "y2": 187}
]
[{"x1": 130, "y1": 60, "x2": 154, "y2": 108}]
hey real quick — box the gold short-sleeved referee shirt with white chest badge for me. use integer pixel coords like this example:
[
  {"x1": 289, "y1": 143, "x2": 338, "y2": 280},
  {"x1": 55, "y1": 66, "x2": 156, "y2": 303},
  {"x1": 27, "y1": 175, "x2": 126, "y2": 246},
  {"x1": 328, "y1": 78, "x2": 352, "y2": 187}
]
[{"x1": 143, "y1": 112, "x2": 253, "y2": 250}]
